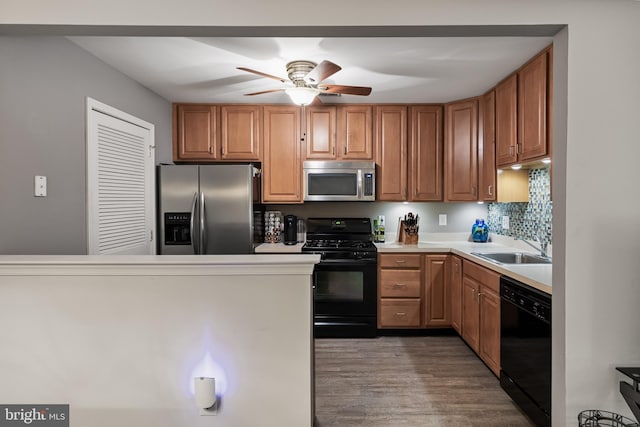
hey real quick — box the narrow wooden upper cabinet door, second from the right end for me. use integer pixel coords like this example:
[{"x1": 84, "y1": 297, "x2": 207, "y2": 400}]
[{"x1": 495, "y1": 73, "x2": 518, "y2": 167}]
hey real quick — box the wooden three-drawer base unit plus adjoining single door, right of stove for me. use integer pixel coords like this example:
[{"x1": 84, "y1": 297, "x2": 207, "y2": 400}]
[{"x1": 378, "y1": 253, "x2": 451, "y2": 329}]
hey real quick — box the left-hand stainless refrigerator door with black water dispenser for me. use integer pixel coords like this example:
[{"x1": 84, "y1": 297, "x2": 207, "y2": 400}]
[{"x1": 157, "y1": 165, "x2": 199, "y2": 255}]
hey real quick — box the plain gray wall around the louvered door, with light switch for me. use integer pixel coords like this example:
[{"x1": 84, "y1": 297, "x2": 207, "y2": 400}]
[{"x1": 0, "y1": 37, "x2": 171, "y2": 254}]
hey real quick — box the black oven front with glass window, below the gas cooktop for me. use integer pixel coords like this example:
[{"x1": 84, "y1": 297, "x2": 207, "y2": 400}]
[{"x1": 313, "y1": 260, "x2": 377, "y2": 337}]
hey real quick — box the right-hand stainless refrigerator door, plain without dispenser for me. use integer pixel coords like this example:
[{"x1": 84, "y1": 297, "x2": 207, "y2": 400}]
[{"x1": 200, "y1": 165, "x2": 253, "y2": 254}]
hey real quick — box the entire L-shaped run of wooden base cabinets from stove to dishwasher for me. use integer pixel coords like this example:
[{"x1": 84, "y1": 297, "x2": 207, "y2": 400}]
[{"x1": 378, "y1": 253, "x2": 500, "y2": 376}]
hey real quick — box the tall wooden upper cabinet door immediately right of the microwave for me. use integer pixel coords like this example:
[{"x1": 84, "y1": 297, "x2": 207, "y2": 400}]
[{"x1": 375, "y1": 105, "x2": 407, "y2": 201}]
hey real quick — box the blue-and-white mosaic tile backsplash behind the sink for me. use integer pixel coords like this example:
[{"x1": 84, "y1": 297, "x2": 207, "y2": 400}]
[{"x1": 487, "y1": 168, "x2": 552, "y2": 243}]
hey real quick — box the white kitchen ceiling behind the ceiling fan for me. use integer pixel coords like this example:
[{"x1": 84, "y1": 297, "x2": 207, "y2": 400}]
[{"x1": 69, "y1": 36, "x2": 552, "y2": 103}]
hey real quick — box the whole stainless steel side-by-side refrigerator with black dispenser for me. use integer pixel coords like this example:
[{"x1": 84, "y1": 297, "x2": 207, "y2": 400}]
[{"x1": 157, "y1": 165, "x2": 261, "y2": 255}]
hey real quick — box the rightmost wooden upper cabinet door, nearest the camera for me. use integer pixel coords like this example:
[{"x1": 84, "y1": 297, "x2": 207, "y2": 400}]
[{"x1": 518, "y1": 49, "x2": 550, "y2": 162}]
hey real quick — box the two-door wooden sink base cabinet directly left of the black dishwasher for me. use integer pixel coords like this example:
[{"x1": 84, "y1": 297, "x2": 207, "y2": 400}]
[{"x1": 462, "y1": 260, "x2": 500, "y2": 376}]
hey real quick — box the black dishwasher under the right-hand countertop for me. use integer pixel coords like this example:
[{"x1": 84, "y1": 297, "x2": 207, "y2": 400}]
[{"x1": 500, "y1": 276, "x2": 551, "y2": 427}]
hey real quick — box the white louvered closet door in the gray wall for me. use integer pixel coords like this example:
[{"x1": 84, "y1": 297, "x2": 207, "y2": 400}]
[{"x1": 87, "y1": 98, "x2": 155, "y2": 255}]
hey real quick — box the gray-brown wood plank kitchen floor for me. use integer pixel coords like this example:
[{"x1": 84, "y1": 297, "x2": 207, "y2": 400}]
[{"x1": 315, "y1": 336, "x2": 533, "y2": 427}]
